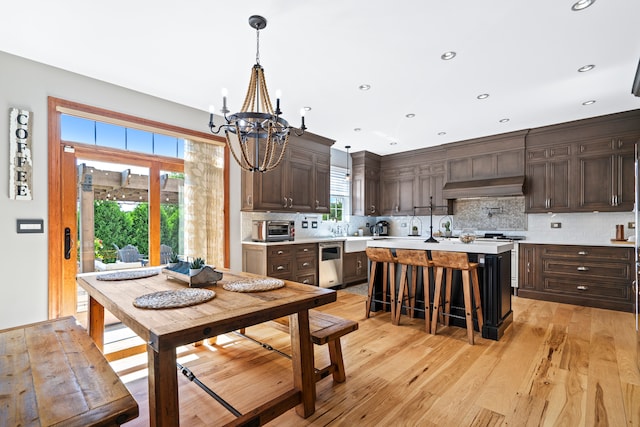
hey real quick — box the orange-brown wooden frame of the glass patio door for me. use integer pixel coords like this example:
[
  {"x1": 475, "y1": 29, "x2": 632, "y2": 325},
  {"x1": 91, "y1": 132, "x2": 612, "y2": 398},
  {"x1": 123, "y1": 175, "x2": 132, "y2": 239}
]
[{"x1": 48, "y1": 97, "x2": 230, "y2": 319}]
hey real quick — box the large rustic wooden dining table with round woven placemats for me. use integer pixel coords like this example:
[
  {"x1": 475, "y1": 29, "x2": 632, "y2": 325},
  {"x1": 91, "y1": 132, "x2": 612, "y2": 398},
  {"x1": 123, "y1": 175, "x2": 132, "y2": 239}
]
[{"x1": 77, "y1": 268, "x2": 336, "y2": 426}]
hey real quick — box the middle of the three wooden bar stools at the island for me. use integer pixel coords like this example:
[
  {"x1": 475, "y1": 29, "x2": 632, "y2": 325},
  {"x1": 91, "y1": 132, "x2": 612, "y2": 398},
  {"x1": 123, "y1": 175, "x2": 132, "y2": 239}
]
[{"x1": 393, "y1": 249, "x2": 433, "y2": 332}]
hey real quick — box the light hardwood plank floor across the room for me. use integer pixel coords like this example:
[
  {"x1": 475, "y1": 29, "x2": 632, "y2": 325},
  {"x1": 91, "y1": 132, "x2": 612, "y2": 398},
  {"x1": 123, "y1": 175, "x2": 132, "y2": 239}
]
[{"x1": 113, "y1": 291, "x2": 640, "y2": 427}]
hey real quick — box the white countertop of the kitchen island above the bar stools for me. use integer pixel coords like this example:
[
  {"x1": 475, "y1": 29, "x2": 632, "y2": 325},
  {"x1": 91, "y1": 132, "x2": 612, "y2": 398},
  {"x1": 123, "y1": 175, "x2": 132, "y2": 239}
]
[{"x1": 367, "y1": 237, "x2": 513, "y2": 254}]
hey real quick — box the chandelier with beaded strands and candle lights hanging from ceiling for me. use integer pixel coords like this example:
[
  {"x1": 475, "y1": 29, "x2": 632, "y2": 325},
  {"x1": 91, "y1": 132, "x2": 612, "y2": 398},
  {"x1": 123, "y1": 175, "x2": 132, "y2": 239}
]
[{"x1": 209, "y1": 15, "x2": 307, "y2": 172}]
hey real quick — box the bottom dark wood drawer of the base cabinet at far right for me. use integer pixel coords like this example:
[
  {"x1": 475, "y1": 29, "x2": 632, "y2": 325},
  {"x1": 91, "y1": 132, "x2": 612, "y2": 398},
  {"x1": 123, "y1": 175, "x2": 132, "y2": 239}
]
[{"x1": 544, "y1": 277, "x2": 631, "y2": 302}]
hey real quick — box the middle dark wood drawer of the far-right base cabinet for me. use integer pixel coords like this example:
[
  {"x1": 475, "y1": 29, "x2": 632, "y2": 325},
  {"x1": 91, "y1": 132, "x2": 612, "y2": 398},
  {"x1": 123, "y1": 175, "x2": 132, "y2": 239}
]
[{"x1": 542, "y1": 259, "x2": 631, "y2": 282}]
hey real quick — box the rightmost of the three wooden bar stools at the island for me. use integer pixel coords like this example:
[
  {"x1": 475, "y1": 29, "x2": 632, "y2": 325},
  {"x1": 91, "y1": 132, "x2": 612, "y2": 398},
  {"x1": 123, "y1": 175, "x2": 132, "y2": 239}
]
[{"x1": 431, "y1": 251, "x2": 484, "y2": 344}]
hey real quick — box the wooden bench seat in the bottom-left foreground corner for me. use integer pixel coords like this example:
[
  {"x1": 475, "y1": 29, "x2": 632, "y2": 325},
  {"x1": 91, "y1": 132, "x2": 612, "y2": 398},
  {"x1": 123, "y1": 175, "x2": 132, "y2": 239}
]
[{"x1": 0, "y1": 317, "x2": 138, "y2": 427}]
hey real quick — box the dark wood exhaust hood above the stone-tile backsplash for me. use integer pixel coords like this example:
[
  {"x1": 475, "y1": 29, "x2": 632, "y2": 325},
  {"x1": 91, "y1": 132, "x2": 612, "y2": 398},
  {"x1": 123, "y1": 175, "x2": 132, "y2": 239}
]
[{"x1": 442, "y1": 176, "x2": 524, "y2": 199}]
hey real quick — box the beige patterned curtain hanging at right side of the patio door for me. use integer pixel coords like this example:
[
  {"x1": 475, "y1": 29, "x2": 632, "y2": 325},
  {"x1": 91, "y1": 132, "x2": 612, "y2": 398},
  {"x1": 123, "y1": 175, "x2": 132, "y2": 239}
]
[{"x1": 184, "y1": 140, "x2": 225, "y2": 267}]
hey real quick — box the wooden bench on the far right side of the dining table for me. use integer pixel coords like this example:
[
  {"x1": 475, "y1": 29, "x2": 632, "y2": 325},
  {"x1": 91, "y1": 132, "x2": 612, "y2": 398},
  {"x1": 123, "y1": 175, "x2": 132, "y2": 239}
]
[{"x1": 196, "y1": 310, "x2": 358, "y2": 383}]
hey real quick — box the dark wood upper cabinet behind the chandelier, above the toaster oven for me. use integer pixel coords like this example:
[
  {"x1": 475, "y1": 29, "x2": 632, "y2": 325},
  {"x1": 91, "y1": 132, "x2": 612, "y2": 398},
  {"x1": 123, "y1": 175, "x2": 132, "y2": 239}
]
[{"x1": 242, "y1": 132, "x2": 335, "y2": 213}]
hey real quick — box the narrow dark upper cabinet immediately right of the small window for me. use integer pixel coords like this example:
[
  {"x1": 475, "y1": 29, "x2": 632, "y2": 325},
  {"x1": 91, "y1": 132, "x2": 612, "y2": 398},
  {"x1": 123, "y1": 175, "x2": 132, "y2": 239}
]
[{"x1": 351, "y1": 151, "x2": 380, "y2": 216}]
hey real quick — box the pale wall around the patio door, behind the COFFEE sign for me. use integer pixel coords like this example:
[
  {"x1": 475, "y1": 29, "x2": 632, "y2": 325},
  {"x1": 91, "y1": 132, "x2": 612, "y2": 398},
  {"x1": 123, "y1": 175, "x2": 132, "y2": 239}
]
[{"x1": 0, "y1": 52, "x2": 242, "y2": 329}]
